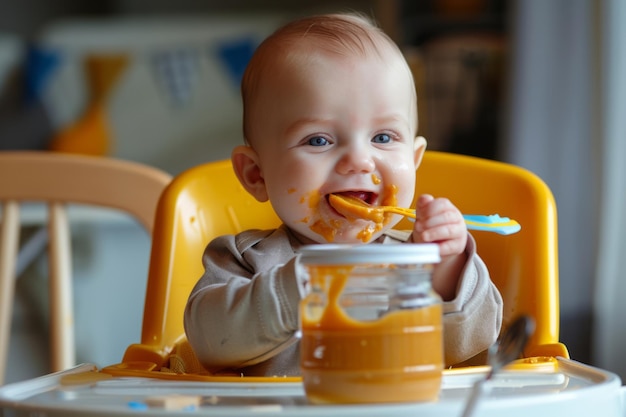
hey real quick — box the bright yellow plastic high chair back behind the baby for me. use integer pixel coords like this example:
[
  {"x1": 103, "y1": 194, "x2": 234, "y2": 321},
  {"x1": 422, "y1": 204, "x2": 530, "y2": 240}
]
[{"x1": 121, "y1": 151, "x2": 568, "y2": 370}]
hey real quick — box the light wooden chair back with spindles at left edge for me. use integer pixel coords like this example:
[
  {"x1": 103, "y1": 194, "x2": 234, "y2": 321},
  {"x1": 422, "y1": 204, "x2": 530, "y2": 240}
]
[{"x1": 0, "y1": 151, "x2": 171, "y2": 385}]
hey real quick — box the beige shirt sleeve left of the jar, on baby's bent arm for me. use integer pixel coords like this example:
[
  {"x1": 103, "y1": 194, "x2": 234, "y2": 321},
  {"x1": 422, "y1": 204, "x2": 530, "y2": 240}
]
[{"x1": 184, "y1": 229, "x2": 304, "y2": 371}]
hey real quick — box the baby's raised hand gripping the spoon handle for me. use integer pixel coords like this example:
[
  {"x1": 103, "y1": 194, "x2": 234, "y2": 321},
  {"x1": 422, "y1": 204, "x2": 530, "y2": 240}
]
[{"x1": 412, "y1": 194, "x2": 467, "y2": 258}]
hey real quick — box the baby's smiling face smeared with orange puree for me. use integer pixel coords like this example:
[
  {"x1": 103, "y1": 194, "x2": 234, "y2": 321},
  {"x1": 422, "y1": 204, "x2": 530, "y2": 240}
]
[{"x1": 246, "y1": 47, "x2": 416, "y2": 243}]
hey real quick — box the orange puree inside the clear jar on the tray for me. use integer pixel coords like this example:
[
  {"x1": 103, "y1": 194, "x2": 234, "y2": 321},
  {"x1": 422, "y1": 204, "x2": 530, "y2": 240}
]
[{"x1": 300, "y1": 265, "x2": 443, "y2": 403}]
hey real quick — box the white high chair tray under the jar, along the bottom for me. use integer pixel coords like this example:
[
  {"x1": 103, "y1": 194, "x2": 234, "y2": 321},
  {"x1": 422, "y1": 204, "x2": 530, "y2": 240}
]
[{"x1": 0, "y1": 358, "x2": 626, "y2": 417}]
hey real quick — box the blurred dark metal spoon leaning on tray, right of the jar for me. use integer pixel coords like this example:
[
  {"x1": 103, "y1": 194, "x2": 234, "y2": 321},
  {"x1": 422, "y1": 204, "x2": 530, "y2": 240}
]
[{"x1": 462, "y1": 315, "x2": 535, "y2": 417}]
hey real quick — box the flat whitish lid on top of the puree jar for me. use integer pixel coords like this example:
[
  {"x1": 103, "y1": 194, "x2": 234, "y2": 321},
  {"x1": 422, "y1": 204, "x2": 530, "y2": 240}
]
[{"x1": 299, "y1": 243, "x2": 441, "y2": 265}]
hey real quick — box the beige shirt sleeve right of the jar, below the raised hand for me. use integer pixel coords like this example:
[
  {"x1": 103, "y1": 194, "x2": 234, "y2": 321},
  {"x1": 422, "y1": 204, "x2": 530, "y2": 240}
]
[{"x1": 443, "y1": 235, "x2": 502, "y2": 366}]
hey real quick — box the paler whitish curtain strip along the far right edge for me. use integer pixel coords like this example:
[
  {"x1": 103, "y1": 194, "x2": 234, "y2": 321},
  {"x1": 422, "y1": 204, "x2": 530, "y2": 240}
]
[{"x1": 593, "y1": 0, "x2": 626, "y2": 376}]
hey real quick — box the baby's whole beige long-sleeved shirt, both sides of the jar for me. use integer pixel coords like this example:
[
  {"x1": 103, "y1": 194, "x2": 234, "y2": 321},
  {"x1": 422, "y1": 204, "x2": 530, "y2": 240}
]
[{"x1": 185, "y1": 225, "x2": 502, "y2": 376}]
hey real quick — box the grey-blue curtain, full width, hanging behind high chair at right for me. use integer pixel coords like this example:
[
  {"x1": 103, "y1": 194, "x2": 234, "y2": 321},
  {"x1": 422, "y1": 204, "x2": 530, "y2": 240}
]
[{"x1": 502, "y1": 0, "x2": 626, "y2": 380}]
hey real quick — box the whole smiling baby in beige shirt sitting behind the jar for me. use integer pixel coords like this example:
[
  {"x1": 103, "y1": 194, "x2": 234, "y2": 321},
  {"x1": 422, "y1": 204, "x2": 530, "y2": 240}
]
[{"x1": 185, "y1": 15, "x2": 502, "y2": 375}]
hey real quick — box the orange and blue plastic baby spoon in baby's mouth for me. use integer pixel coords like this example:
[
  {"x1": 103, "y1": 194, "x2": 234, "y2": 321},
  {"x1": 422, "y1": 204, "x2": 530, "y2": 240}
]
[{"x1": 328, "y1": 194, "x2": 522, "y2": 235}]
